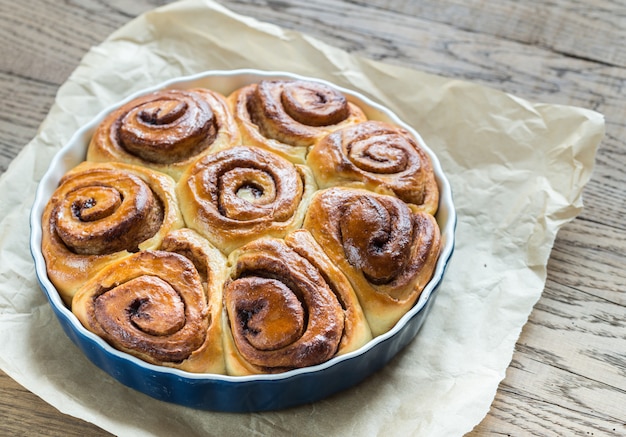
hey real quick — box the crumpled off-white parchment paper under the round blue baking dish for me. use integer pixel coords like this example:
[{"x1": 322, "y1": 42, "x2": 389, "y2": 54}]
[{"x1": 0, "y1": 0, "x2": 604, "y2": 436}]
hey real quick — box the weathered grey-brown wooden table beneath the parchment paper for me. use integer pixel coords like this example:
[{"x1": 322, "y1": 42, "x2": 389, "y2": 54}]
[{"x1": 0, "y1": 0, "x2": 626, "y2": 437}]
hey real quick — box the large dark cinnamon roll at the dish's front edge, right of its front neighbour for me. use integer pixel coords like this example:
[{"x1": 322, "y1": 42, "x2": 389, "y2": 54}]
[{"x1": 224, "y1": 232, "x2": 356, "y2": 375}]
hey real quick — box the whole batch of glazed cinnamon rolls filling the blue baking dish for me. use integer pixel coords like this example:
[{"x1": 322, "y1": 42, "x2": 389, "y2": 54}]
[{"x1": 42, "y1": 76, "x2": 440, "y2": 375}]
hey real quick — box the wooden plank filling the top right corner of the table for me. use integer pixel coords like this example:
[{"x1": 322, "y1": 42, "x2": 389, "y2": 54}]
[{"x1": 348, "y1": 0, "x2": 626, "y2": 67}]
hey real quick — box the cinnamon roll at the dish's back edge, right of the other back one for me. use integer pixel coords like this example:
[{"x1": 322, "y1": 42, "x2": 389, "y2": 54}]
[{"x1": 228, "y1": 80, "x2": 366, "y2": 163}]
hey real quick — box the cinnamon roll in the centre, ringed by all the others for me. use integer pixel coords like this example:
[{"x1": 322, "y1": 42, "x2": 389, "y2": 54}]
[{"x1": 177, "y1": 146, "x2": 316, "y2": 253}]
